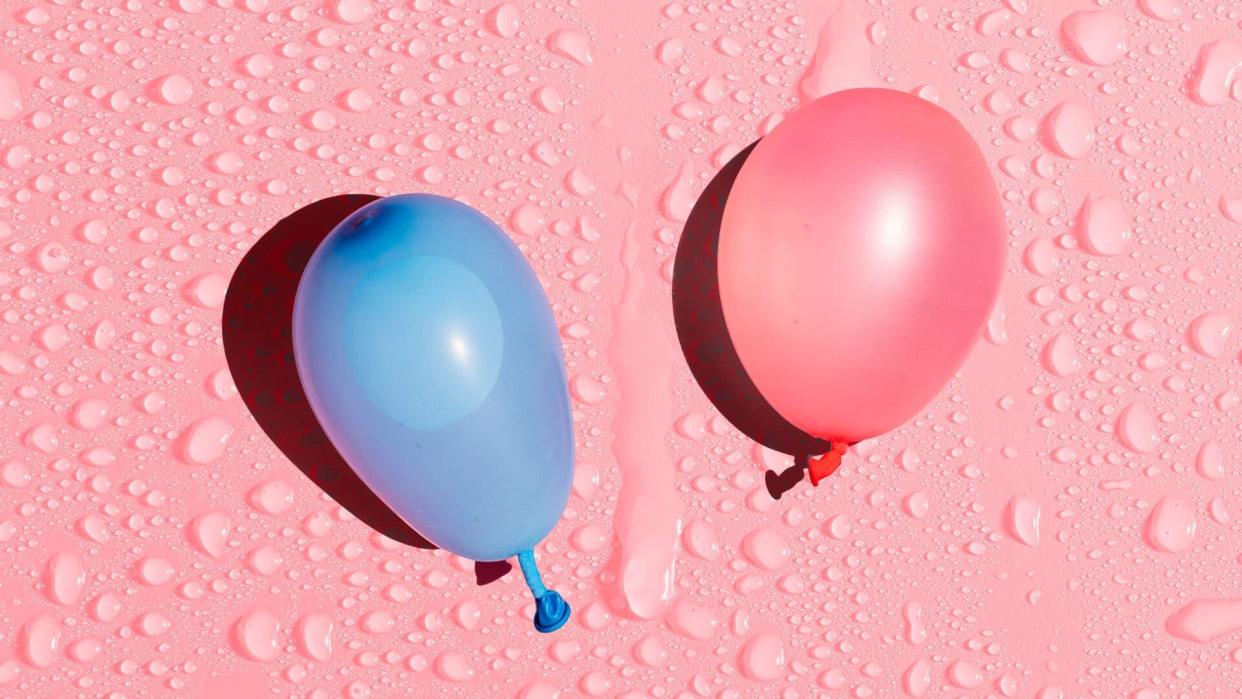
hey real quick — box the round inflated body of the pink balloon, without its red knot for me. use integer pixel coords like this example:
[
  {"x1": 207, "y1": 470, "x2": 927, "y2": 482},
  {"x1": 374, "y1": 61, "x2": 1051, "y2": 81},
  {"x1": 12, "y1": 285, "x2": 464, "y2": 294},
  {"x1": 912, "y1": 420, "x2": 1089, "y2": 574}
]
[{"x1": 719, "y1": 88, "x2": 1005, "y2": 442}]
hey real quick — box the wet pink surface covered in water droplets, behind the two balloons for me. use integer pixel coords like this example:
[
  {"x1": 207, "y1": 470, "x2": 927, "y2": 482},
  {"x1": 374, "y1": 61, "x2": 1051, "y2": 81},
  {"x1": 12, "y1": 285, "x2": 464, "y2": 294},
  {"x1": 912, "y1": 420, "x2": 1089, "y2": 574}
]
[{"x1": 0, "y1": 0, "x2": 1242, "y2": 699}]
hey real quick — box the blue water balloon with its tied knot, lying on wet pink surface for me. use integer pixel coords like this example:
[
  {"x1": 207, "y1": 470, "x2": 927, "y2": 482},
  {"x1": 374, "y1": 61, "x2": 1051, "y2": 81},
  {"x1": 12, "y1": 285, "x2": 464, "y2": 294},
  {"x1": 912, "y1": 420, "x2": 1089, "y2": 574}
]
[{"x1": 293, "y1": 194, "x2": 574, "y2": 632}]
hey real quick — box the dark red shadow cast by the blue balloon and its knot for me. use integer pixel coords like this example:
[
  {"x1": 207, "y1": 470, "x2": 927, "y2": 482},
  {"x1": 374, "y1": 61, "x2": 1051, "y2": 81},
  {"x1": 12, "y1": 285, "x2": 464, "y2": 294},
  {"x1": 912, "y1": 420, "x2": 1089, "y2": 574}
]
[{"x1": 224, "y1": 194, "x2": 513, "y2": 585}]
